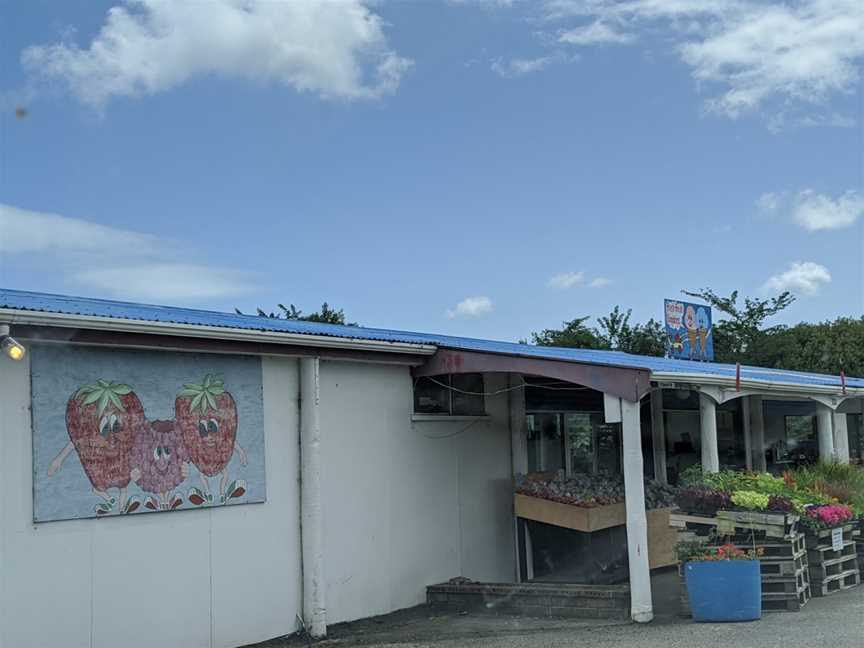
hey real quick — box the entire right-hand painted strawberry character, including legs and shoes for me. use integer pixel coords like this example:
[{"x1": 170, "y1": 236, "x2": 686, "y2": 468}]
[{"x1": 174, "y1": 374, "x2": 247, "y2": 505}]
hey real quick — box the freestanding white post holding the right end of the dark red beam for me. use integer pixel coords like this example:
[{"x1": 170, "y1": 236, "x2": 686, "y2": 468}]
[{"x1": 621, "y1": 399, "x2": 654, "y2": 623}]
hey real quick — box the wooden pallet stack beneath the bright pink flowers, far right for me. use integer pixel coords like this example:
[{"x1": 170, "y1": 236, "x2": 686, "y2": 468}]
[{"x1": 807, "y1": 524, "x2": 861, "y2": 596}]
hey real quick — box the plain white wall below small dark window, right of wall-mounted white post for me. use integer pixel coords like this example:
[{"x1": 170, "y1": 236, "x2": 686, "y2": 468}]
[{"x1": 321, "y1": 362, "x2": 515, "y2": 624}]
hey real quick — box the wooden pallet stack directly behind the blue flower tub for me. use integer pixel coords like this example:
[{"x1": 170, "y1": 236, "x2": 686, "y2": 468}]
[{"x1": 670, "y1": 511, "x2": 810, "y2": 615}]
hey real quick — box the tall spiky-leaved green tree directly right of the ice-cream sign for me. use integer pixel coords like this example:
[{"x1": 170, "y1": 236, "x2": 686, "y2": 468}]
[{"x1": 681, "y1": 288, "x2": 795, "y2": 366}]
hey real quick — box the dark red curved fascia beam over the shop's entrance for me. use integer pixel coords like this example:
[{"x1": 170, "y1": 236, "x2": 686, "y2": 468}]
[{"x1": 412, "y1": 349, "x2": 651, "y2": 402}]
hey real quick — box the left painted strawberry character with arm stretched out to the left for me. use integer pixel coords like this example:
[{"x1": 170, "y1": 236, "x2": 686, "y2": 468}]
[{"x1": 48, "y1": 380, "x2": 146, "y2": 515}]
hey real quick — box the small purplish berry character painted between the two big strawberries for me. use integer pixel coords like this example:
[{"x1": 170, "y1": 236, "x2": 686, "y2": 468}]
[{"x1": 130, "y1": 421, "x2": 188, "y2": 511}]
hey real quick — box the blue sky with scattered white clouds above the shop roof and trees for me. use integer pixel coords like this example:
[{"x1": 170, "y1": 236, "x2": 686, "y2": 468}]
[{"x1": 0, "y1": 0, "x2": 864, "y2": 340}]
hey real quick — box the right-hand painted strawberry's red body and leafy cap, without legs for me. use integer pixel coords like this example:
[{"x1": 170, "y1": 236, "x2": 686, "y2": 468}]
[{"x1": 174, "y1": 374, "x2": 237, "y2": 477}]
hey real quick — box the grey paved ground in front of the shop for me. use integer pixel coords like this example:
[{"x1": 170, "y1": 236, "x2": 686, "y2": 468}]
[{"x1": 250, "y1": 587, "x2": 864, "y2": 648}]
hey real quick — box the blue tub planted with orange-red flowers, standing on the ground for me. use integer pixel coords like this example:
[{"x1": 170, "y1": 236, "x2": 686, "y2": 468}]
[{"x1": 678, "y1": 543, "x2": 762, "y2": 623}]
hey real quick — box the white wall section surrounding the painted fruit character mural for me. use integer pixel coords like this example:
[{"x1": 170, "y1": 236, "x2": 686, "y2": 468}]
[{"x1": 0, "y1": 358, "x2": 301, "y2": 648}]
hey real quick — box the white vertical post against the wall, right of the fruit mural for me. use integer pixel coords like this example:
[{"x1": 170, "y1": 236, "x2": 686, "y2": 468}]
[{"x1": 300, "y1": 358, "x2": 327, "y2": 639}]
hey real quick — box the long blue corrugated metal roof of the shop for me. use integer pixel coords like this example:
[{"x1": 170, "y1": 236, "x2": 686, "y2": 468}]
[{"x1": 0, "y1": 289, "x2": 864, "y2": 388}]
